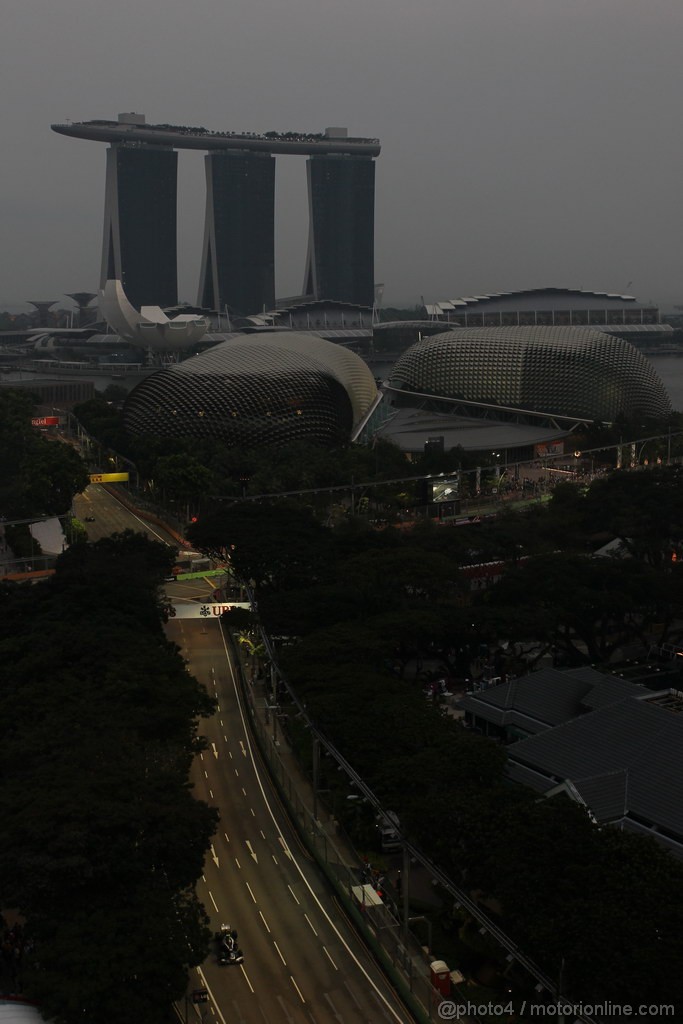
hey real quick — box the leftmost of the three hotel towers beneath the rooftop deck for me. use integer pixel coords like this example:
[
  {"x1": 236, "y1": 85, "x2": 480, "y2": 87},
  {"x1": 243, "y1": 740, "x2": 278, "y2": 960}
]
[{"x1": 99, "y1": 143, "x2": 178, "y2": 309}]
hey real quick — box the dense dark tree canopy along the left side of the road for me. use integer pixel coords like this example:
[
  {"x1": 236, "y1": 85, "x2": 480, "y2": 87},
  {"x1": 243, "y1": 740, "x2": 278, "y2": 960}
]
[{"x1": 0, "y1": 534, "x2": 216, "y2": 1024}]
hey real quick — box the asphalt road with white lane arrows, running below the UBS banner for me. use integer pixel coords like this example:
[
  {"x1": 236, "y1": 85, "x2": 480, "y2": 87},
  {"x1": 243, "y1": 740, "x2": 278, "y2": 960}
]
[{"x1": 167, "y1": 620, "x2": 412, "y2": 1024}]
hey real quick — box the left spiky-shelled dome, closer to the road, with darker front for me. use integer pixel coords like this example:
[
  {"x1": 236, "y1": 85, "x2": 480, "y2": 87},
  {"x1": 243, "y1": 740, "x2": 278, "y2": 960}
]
[{"x1": 124, "y1": 331, "x2": 379, "y2": 447}]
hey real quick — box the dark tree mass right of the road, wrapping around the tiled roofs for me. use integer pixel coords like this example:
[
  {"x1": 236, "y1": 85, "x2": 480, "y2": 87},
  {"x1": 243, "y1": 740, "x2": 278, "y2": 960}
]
[{"x1": 193, "y1": 483, "x2": 683, "y2": 1002}]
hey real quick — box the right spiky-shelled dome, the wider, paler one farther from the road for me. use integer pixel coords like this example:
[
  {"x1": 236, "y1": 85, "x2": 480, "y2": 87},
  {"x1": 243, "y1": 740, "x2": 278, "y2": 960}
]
[{"x1": 387, "y1": 327, "x2": 671, "y2": 422}]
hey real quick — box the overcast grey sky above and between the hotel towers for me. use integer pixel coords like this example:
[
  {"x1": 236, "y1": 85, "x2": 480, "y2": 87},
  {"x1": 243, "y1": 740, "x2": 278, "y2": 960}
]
[{"x1": 0, "y1": 0, "x2": 683, "y2": 310}]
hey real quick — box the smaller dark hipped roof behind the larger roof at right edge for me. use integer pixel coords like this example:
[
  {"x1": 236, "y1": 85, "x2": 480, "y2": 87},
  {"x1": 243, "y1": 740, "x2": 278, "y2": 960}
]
[{"x1": 463, "y1": 668, "x2": 648, "y2": 733}]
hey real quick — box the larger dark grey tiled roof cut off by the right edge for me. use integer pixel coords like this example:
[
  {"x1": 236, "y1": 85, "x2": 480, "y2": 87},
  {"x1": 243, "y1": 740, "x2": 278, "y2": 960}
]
[{"x1": 508, "y1": 697, "x2": 683, "y2": 841}]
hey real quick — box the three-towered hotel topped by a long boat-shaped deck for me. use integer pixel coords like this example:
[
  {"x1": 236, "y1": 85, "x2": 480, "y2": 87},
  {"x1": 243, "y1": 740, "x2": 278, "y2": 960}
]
[{"x1": 51, "y1": 114, "x2": 380, "y2": 315}]
